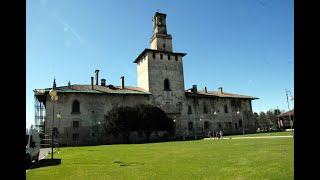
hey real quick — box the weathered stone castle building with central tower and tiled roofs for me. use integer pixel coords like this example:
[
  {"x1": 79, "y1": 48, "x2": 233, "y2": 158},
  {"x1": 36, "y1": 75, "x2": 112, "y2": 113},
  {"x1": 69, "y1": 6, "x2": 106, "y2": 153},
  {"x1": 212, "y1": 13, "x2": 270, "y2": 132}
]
[{"x1": 34, "y1": 12, "x2": 258, "y2": 145}]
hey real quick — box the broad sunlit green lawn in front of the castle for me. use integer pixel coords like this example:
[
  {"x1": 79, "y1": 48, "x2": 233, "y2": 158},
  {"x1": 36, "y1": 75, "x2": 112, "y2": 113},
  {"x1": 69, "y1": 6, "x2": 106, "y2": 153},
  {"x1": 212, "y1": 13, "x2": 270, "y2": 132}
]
[{"x1": 26, "y1": 138, "x2": 294, "y2": 180}]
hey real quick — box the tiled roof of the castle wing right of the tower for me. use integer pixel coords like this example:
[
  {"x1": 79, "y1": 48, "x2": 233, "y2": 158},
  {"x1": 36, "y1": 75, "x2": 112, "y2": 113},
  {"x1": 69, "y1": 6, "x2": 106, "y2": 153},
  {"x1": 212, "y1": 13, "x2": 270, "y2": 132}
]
[{"x1": 186, "y1": 91, "x2": 259, "y2": 100}]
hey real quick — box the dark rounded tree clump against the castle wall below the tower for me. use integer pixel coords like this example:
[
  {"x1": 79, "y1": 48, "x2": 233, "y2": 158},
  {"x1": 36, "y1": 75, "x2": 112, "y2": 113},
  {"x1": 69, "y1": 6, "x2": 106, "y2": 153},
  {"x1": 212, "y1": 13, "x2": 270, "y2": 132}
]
[{"x1": 105, "y1": 104, "x2": 174, "y2": 142}]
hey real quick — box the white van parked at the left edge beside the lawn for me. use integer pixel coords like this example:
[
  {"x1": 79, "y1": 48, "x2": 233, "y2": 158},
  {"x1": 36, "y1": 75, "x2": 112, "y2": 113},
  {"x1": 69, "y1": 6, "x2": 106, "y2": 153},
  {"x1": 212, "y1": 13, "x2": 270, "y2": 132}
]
[{"x1": 26, "y1": 127, "x2": 40, "y2": 168}]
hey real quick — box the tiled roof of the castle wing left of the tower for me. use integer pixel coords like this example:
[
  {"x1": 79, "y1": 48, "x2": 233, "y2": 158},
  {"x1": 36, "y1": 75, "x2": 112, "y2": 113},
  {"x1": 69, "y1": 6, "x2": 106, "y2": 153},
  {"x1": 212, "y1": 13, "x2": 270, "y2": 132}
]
[{"x1": 35, "y1": 85, "x2": 151, "y2": 94}]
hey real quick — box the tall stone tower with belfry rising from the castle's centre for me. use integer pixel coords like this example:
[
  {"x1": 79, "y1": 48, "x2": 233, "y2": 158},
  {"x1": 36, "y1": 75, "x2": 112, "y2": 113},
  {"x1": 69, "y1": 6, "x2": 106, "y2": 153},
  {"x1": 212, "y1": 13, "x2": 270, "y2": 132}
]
[{"x1": 134, "y1": 12, "x2": 186, "y2": 113}]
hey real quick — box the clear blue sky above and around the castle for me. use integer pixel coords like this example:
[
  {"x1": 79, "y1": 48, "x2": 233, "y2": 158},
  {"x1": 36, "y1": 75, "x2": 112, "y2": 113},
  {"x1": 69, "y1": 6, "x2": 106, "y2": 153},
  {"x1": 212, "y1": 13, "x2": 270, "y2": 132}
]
[{"x1": 26, "y1": 0, "x2": 294, "y2": 127}]
